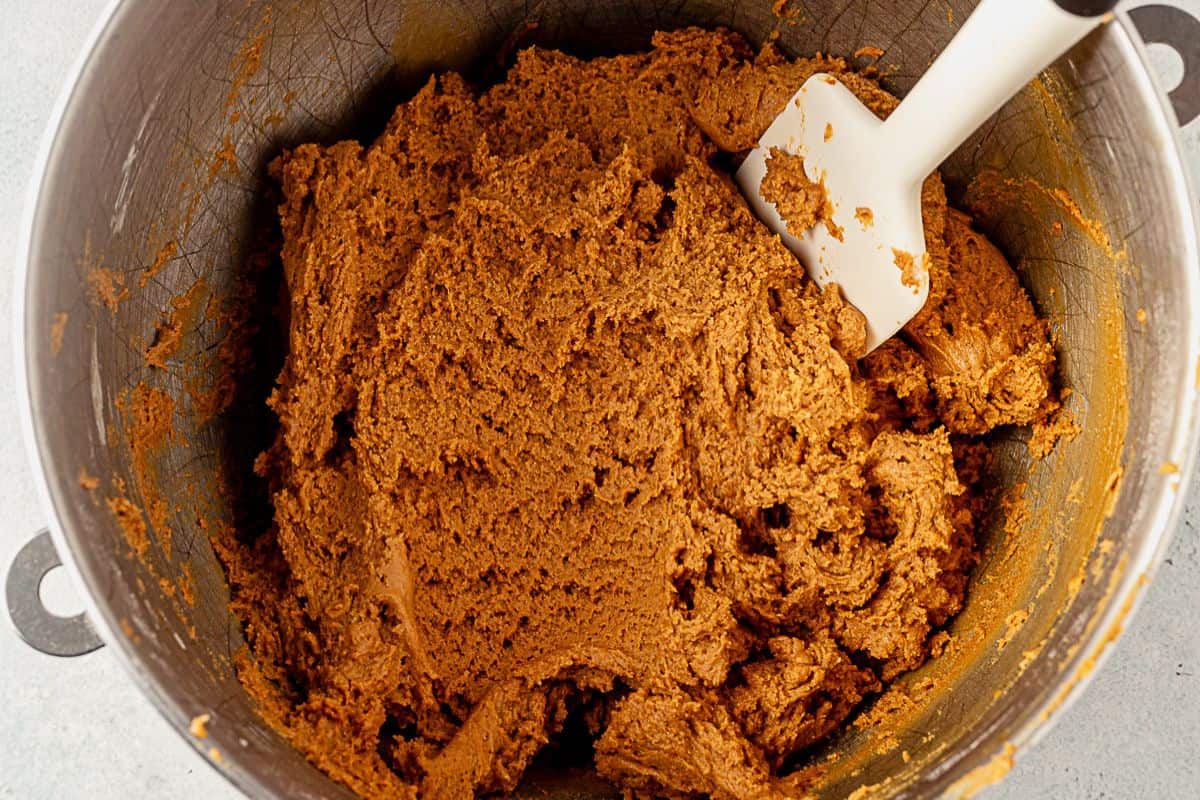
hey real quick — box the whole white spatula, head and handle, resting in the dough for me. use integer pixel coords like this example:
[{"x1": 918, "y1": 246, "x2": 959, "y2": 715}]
[{"x1": 737, "y1": 0, "x2": 1116, "y2": 351}]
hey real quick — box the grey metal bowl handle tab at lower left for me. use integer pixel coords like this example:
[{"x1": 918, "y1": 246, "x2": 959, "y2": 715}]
[{"x1": 5, "y1": 530, "x2": 104, "y2": 657}]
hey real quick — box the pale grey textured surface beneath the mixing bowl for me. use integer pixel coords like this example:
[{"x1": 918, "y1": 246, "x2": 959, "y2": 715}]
[{"x1": 0, "y1": 0, "x2": 1200, "y2": 800}]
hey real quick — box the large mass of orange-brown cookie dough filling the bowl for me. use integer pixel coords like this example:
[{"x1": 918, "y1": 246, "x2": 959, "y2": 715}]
[{"x1": 226, "y1": 30, "x2": 1057, "y2": 799}]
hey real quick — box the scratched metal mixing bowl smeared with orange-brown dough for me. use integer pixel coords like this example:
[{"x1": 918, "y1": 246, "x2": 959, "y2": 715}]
[{"x1": 25, "y1": 0, "x2": 1195, "y2": 798}]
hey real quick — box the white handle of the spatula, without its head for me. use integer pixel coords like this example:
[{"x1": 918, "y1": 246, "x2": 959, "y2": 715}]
[{"x1": 882, "y1": 0, "x2": 1115, "y2": 184}]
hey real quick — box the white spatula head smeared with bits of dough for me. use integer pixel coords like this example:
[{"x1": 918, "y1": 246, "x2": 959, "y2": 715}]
[{"x1": 737, "y1": 73, "x2": 935, "y2": 353}]
